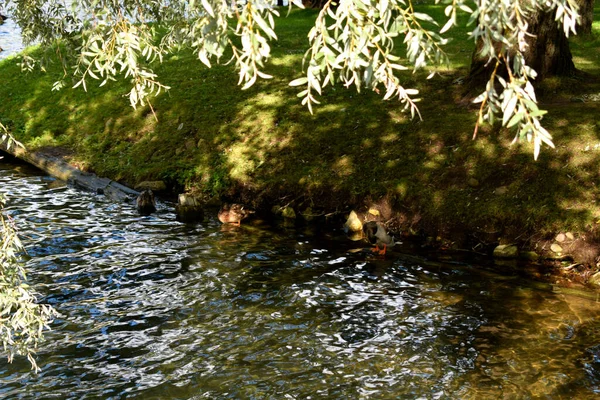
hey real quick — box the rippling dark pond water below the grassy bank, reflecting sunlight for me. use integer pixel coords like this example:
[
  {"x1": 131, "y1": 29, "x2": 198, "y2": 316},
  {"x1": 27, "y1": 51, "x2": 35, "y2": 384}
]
[{"x1": 0, "y1": 161, "x2": 600, "y2": 399}]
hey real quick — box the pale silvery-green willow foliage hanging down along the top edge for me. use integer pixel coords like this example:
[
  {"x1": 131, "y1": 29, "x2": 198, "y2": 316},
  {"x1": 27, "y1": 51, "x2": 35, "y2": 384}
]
[{"x1": 0, "y1": 0, "x2": 579, "y2": 157}]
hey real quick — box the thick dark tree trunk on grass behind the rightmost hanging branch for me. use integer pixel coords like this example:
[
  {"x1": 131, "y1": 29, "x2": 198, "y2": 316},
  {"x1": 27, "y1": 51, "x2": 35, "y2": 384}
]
[{"x1": 467, "y1": 10, "x2": 576, "y2": 87}]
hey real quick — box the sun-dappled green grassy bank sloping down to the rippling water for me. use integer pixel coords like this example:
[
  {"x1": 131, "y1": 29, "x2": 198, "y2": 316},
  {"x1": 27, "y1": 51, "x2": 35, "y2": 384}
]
[{"x1": 0, "y1": 5, "x2": 600, "y2": 260}]
